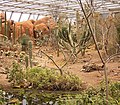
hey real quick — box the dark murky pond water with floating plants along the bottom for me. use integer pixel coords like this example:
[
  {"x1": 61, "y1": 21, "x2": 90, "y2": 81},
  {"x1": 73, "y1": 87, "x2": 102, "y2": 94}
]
[{"x1": 4, "y1": 89, "x2": 80, "y2": 105}]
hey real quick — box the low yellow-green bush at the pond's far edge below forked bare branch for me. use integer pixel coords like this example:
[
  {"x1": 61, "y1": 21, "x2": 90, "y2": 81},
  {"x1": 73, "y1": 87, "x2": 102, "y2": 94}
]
[{"x1": 27, "y1": 67, "x2": 82, "y2": 90}]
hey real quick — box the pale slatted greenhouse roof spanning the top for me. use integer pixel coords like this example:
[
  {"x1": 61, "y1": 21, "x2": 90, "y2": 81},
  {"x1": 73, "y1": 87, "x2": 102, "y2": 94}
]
[{"x1": 0, "y1": 0, "x2": 120, "y2": 21}]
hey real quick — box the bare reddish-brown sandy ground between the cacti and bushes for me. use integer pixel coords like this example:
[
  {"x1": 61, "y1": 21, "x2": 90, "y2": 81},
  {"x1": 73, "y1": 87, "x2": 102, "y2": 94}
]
[{"x1": 0, "y1": 46, "x2": 120, "y2": 89}]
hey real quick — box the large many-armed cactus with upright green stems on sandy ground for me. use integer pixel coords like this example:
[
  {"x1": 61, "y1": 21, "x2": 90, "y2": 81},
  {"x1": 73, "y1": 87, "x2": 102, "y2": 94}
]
[{"x1": 56, "y1": 11, "x2": 91, "y2": 60}]
